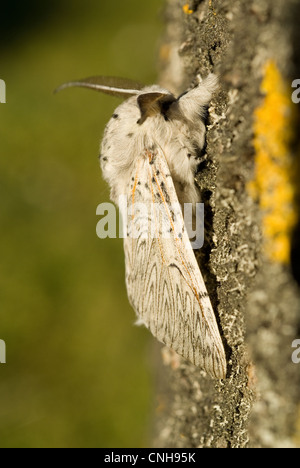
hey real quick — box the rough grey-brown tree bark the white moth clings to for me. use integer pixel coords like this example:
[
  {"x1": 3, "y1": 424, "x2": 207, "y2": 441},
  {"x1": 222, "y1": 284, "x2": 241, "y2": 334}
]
[{"x1": 153, "y1": 0, "x2": 300, "y2": 448}]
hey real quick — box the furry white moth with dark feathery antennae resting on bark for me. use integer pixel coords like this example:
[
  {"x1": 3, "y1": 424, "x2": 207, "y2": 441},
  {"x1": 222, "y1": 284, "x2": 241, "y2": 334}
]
[{"x1": 56, "y1": 74, "x2": 226, "y2": 379}]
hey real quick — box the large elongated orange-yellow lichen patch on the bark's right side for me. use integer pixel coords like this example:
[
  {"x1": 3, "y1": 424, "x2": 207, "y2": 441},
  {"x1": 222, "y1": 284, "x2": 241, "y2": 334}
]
[{"x1": 249, "y1": 61, "x2": 297, "y2": 263}]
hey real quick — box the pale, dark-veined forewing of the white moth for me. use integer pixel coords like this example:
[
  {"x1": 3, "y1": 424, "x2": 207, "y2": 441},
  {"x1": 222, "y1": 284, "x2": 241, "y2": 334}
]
[{"x1": 124, "y1": 151, "x2": 226, "y2": 379}]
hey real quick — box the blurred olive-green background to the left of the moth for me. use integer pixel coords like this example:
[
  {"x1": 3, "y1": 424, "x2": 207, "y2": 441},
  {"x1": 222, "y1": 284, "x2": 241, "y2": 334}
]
[{"x1": 0, "y1": 0, "x2": 163, "y2": 448}]
